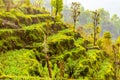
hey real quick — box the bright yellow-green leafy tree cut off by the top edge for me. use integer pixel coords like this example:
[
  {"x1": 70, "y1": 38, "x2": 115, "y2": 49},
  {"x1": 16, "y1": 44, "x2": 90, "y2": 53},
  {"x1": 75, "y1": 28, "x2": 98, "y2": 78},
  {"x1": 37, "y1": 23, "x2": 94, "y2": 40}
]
[{"x1": 51, "y1": 0, "x2": 63, "y2": 16}]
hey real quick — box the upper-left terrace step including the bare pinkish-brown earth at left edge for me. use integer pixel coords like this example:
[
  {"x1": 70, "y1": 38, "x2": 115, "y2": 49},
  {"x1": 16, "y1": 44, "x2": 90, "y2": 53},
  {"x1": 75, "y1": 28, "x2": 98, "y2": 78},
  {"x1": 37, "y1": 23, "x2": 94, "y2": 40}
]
[{"x1": 0, "y1": 12, "x2": 54, "y2": 28}]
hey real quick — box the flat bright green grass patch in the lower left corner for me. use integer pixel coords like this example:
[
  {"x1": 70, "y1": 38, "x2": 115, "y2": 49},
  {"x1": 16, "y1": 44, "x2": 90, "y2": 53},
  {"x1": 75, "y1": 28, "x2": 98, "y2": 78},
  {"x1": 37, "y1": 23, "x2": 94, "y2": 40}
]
[{"x1": 0, "y1": 49, "x2": 39, "y2": 76}]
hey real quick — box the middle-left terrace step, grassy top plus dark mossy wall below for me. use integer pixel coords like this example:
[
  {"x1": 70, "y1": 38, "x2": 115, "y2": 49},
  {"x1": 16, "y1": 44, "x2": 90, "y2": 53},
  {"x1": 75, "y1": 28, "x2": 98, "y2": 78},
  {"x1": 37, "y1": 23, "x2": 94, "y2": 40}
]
[{"x1": 0, "y1": 22, "x2": 67, "y2": 51}]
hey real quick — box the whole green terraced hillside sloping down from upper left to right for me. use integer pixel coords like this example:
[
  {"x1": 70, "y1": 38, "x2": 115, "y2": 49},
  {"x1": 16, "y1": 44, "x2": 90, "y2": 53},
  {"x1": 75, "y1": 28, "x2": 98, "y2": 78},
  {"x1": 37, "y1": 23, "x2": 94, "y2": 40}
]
[{"x1": 0, "y1": 1, "x2": 119, "y2": 80}]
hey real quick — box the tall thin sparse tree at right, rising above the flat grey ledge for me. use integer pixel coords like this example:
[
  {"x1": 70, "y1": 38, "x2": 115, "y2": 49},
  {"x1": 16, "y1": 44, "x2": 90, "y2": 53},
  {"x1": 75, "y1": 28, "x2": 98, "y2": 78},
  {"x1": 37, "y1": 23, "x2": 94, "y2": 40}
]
[{"x1": 93, "y1": 10, "x2": 99, "y2": 46}]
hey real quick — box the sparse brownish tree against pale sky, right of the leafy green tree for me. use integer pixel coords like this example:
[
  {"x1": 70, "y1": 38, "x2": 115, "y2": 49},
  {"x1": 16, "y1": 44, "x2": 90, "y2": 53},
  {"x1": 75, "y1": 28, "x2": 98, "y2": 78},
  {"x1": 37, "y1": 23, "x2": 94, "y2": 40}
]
[{"x1": 71, "y1": 2, "x2": 80, "y2": 29}]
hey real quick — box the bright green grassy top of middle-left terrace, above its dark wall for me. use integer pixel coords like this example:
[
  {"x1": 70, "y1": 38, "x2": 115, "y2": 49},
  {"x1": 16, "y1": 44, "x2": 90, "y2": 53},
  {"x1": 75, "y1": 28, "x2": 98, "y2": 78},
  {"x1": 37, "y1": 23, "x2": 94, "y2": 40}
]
[{"x1": 0, "y1": 22, "x2": 65, "y2": 39}]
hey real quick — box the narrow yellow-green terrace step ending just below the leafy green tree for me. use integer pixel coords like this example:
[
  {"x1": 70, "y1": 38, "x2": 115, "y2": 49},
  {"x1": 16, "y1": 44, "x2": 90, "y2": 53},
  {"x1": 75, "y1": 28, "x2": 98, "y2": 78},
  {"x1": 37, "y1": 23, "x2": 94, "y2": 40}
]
[{"x1": 16, "y1": 14, "x2": 54, "y2": 25}]
